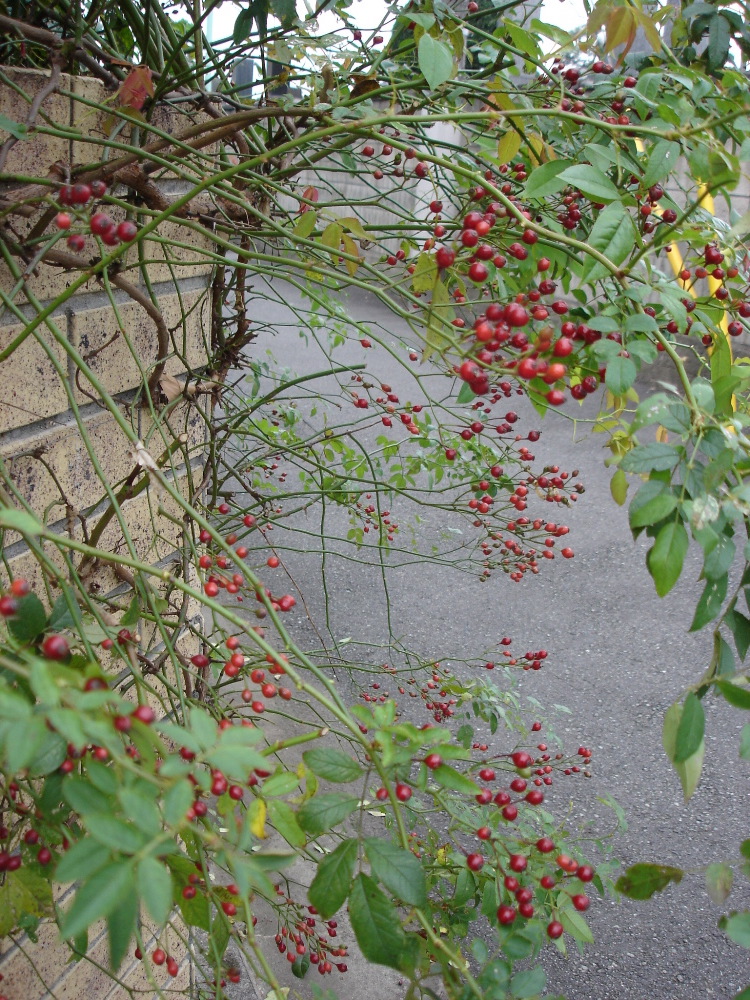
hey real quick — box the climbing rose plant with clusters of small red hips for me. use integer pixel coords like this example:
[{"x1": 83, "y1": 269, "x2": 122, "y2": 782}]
[{"x1": 0, "y1": 0, "x2": 750, "y2": 1000}]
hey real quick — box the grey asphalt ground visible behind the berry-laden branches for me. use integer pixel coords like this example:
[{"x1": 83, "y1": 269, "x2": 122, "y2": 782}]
[{"x1": 223, "y1": 284, "x2": 750, "y2": 1000}]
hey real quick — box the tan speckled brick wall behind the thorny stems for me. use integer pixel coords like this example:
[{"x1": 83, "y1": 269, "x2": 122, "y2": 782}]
[{"x1": 0, "y1": 69, "x2": 217, "y2": 1000}]
